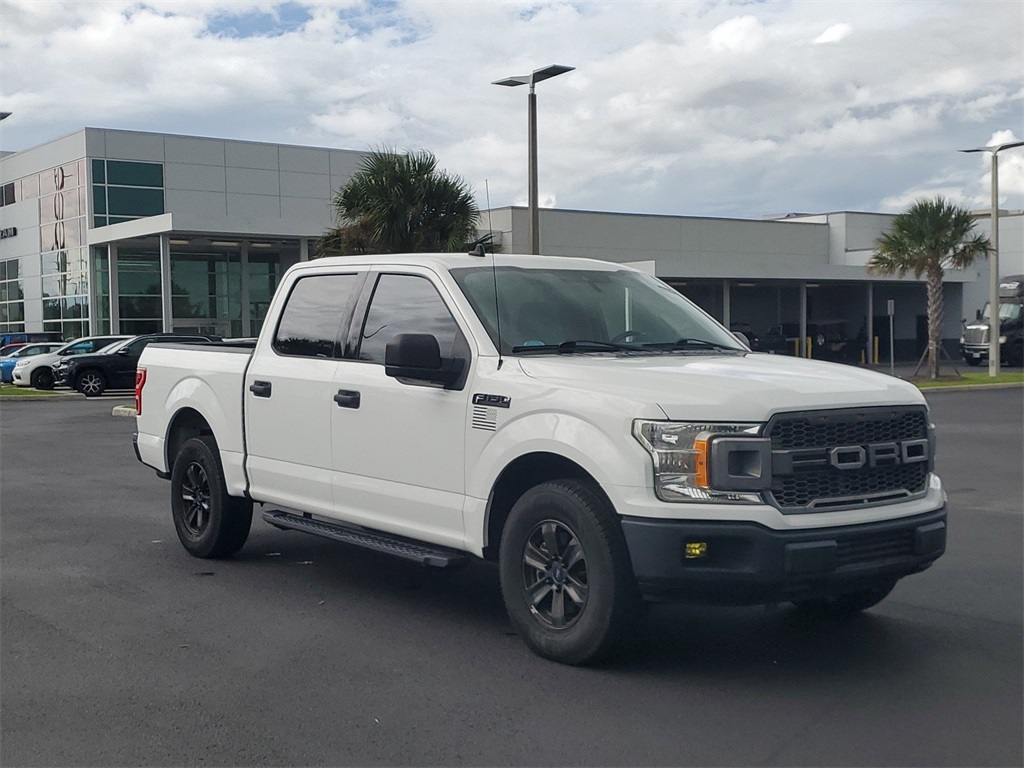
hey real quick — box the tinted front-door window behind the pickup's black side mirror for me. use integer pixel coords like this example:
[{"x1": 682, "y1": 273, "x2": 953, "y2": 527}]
[{"x1": 359, "y1": 274, "x2": 460, "y2": 365}]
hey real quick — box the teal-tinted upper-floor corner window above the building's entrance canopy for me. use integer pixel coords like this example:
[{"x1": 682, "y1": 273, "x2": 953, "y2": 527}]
[{"x1": 92, "y1": 158, "x2": 164, "y2": 226}]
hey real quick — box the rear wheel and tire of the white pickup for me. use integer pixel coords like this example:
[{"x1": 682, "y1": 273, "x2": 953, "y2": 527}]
[{"x1": 171, "y1": 435, "x2": 253, "y2": 559}]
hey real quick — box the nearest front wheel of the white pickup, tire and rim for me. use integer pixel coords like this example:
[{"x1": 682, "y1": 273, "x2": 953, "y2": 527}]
[{"x1": 499, "y1": 480, "x2": 640, "y2": 665}]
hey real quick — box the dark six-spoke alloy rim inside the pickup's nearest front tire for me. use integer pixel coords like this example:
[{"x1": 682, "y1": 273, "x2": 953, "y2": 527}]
[{"x1": 522, "y1": 520, "x2": 590, "y2": 630}]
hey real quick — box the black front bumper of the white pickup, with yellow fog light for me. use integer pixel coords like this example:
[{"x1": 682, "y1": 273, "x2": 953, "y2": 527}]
[{"x1": 622, "y1": 505, "x2": 946, "y2": 605}]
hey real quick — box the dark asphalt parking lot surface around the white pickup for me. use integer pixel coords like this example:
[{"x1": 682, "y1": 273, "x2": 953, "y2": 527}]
[{"x1": 0, "y1": 388, "x2": 1024, "y2": 766}]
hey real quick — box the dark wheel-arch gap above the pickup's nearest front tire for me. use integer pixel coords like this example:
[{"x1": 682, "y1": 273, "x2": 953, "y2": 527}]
[{"x1": 483, "y1": 451, "x2": 614, "y2": 560}]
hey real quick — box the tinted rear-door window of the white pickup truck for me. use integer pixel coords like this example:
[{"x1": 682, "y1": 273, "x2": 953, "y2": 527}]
[{"x1": 273, "y1": 274, "x2": 359, "y2": 357}]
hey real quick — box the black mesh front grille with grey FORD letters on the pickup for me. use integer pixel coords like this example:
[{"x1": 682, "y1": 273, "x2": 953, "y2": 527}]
[{"x1": 765, "y1": 407, "x2": 932, "y2": 512}]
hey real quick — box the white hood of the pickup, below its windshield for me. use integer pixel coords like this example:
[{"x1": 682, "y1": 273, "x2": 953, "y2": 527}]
[{"x1": 519, "y1": 353, "x2": 925, "y2": 422}]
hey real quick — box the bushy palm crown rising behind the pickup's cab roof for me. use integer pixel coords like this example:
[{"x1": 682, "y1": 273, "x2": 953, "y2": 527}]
[{"x1": 316, "y1": 148, "x2": 479, "y2": 256}]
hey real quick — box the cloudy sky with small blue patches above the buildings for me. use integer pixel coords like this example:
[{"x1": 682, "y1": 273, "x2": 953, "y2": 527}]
[{"x1": 0, "y1": 0, "x2": 1024, "y2": 218}]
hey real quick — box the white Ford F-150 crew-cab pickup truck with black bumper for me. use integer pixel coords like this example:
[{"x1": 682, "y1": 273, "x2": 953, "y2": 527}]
[{"x1": 135, "y1": 254, "x2": 946, "y2": 664}]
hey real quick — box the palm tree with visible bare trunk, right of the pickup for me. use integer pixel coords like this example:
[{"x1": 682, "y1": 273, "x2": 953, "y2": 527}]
[{"x1": 867, "y1": 197, "x2": 992, "y2": 379}]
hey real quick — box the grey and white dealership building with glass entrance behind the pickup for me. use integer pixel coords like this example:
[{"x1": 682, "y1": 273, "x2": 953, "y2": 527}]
[{"x1": 0, "y1": 128, "x2": 1024, "y2": 359}]
